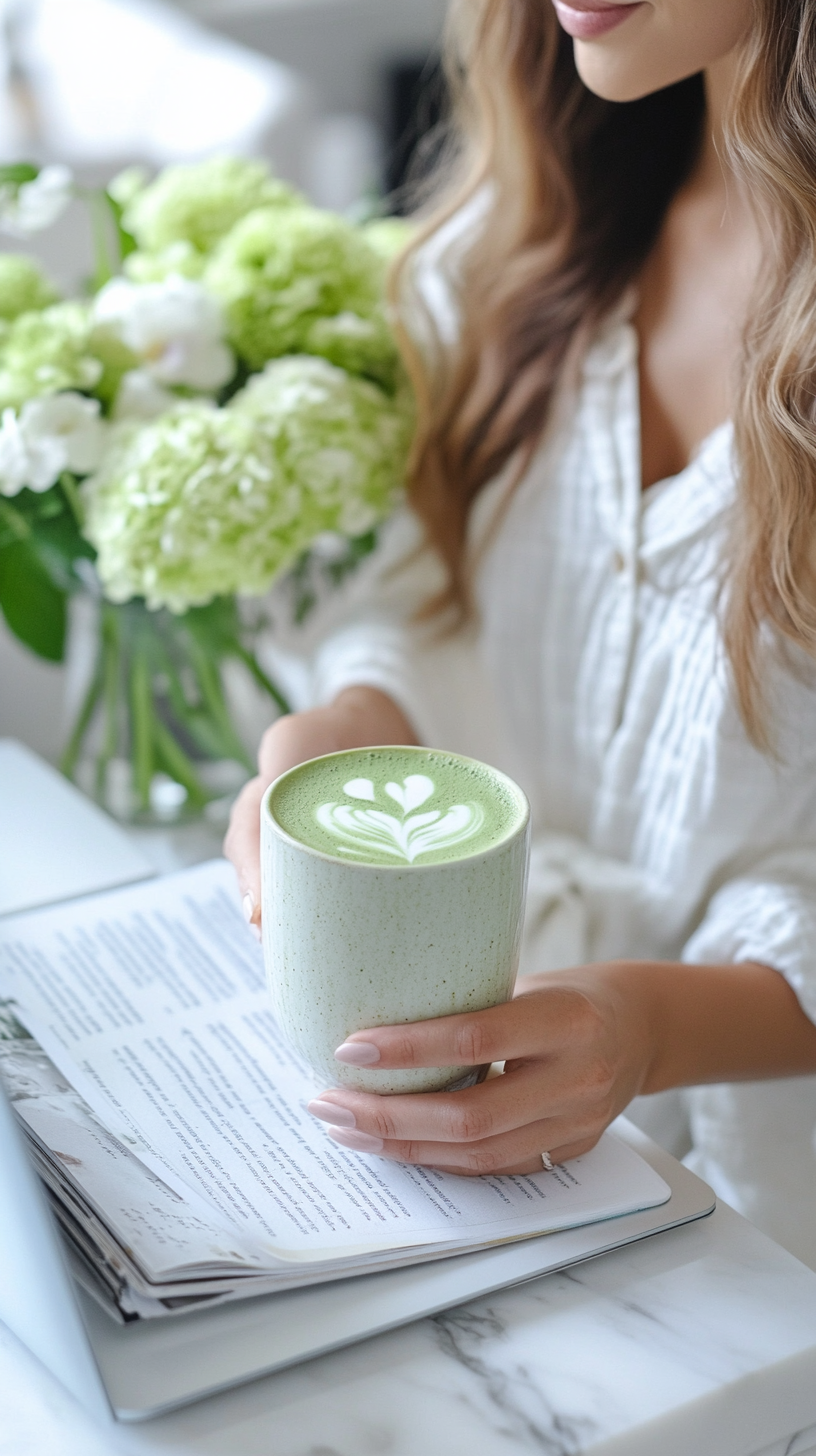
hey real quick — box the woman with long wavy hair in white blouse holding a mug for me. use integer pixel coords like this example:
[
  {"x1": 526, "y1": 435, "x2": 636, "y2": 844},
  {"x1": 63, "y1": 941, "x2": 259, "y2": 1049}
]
[{"x1": 227, "y1": 0, "x2": 816, "y2": 1262}]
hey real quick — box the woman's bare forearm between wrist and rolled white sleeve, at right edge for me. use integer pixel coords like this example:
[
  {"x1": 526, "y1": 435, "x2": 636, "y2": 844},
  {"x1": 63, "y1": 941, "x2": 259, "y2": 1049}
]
[{"x1": 622, "y1": 962, "x2": 816, "y2": 1092}]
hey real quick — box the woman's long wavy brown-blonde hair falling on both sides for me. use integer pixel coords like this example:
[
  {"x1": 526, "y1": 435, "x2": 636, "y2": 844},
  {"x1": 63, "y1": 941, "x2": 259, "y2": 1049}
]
[{"x1": 395, "y1": 0, "x2": 816, "y2": 747}]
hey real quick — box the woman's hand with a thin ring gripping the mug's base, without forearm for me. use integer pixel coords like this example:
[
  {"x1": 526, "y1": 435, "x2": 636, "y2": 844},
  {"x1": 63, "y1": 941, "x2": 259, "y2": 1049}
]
[{"x1": 309, "y1": 962, "x2": 654, "y2": 1174}]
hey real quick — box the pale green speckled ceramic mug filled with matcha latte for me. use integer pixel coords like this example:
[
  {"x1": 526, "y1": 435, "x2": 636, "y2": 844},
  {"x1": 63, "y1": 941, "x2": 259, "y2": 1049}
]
[{"x1": 261, "y1": 747, "x2": 529, "y2": 1093}]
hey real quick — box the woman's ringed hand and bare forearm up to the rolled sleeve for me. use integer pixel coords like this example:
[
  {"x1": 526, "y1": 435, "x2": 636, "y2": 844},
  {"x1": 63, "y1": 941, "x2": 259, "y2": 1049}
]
[{"x1": 309, "y1": 961, "x2": 816, "y2": 1174}]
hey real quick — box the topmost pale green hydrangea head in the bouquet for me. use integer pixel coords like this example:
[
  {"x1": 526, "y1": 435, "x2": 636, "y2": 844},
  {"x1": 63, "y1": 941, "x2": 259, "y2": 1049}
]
[{"x1": 122, "y1": 157, "x2": 297, "y2": 253}]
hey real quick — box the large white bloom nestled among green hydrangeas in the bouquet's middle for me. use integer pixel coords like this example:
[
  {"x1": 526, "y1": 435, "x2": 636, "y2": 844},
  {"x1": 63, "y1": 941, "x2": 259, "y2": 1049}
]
[{"x1": 93, "y1": 274, "x2": 235, "y2": 390}]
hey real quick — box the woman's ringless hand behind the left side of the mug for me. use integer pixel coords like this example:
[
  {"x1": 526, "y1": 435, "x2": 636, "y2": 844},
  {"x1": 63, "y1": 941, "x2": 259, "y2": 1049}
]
[{"x1": 224, "y1": 687, "x2": 417, "y2": 926}]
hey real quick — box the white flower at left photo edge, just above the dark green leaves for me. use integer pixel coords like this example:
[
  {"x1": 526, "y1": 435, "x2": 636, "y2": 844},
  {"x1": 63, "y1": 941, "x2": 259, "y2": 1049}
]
[{"x1": 0, "y1": 392, "x2": 105, "y2": 495}]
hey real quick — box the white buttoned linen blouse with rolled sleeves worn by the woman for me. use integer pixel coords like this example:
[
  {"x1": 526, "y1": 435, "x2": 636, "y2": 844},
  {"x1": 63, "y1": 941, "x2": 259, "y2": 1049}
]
[{"x1": 301, "y1": 316, "x2": 816, "y2": 1267}]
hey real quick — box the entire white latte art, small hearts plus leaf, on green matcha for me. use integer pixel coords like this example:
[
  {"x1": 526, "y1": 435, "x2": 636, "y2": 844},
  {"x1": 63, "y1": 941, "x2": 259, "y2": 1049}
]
[{"x1": 316, "y1": 773, "x2": 484, "y2": 865}]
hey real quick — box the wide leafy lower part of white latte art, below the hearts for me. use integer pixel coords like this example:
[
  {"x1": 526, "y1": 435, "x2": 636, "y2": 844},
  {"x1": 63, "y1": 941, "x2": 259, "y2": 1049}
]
[{"x1": 318, "y1": 797, "x2": 484, "y2": 865}]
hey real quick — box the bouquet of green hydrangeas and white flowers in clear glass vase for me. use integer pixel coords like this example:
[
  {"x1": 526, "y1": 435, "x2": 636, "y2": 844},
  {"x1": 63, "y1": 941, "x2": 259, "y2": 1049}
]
[{"x1": 0, "y1": 159, "x2": 411, "y2": 818}]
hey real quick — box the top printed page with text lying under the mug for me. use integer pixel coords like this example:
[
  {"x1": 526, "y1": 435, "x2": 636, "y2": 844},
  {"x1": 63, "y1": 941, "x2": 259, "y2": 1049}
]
[{"x1": 0, "y1": 860, "x2": 670, "y2": 1267}]
